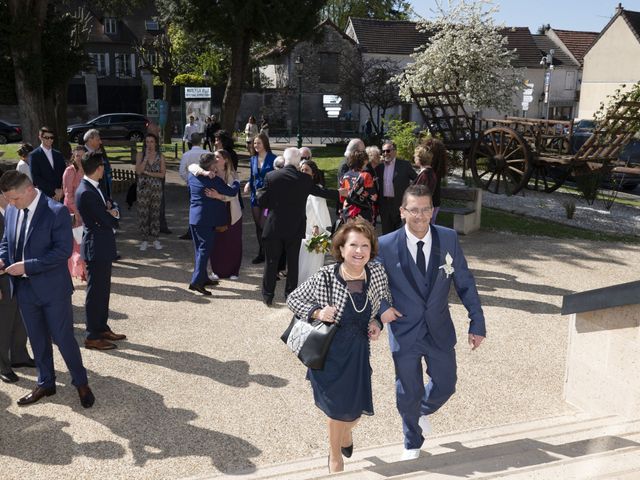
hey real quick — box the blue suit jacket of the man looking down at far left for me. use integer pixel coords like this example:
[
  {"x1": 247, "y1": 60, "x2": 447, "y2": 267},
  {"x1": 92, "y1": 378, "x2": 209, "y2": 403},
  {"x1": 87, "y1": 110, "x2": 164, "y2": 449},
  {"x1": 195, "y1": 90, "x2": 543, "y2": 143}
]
[{"x1": 0, "y1": 195, "x2": 73, "y2": 303}]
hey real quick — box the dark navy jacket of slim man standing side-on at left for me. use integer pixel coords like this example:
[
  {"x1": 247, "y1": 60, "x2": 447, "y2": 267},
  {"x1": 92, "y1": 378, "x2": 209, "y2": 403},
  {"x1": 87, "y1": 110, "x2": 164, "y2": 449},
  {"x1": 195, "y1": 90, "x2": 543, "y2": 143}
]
[{"x1": 76, "y1": 178, "x2": 118, "y2": 262}]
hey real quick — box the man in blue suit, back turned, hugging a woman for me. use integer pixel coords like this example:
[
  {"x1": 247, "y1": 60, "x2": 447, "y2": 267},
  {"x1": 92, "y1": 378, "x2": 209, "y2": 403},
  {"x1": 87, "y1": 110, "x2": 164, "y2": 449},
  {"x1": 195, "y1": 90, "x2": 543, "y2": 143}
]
[{"x1": 187, "y1": 153, "x2": 240, "y2": 295}]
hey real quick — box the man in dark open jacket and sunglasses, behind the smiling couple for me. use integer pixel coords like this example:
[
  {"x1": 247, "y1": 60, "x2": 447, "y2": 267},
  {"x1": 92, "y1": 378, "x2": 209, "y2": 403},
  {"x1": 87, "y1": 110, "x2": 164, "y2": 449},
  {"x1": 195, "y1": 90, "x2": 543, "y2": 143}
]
[{"x1": 376, "y1": 140, "x2": 417, "y2": 234}]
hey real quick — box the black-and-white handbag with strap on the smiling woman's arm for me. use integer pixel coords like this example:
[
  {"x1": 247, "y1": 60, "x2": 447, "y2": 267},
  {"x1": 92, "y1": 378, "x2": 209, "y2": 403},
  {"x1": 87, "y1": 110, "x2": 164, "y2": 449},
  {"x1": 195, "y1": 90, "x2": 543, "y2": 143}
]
[{"x1": 280, "y1": 272, "x2": 340, "y2": 370}]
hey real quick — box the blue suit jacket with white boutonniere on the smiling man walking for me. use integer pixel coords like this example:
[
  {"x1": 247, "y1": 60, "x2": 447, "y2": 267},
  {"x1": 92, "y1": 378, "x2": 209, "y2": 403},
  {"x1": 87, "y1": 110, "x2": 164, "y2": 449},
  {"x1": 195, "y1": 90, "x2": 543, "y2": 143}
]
[{"x1": 377, "y1": 225, "x2": 486, "y2": 353}]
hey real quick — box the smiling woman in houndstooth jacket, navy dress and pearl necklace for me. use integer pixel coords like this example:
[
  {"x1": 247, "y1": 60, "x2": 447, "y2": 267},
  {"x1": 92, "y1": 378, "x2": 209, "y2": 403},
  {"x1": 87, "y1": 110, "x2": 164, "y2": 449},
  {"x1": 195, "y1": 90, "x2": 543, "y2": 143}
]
[{"x1": 287, "y1": 218, "x2": 392, "y2": 473}]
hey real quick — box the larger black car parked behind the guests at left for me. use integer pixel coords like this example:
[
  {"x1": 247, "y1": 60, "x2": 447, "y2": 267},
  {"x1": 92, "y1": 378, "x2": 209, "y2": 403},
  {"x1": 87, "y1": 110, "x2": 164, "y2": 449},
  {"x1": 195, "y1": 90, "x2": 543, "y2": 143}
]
[{"x1": 67, "y1": 113, "x2": 149, "y2": 143}]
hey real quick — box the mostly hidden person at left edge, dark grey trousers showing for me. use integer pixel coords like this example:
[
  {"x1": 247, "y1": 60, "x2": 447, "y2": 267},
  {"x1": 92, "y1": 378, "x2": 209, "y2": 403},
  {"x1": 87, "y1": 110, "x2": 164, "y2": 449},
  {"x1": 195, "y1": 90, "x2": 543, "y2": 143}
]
[{"x1": 0, "y1": 170, "x2": 36, "y2": 383}]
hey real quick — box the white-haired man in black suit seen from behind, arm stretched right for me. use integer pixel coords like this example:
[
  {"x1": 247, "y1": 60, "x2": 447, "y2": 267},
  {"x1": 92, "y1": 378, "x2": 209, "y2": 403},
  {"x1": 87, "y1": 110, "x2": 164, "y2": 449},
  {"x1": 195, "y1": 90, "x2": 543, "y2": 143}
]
[{"x1": 258, "y1": 147, "x2": 346, "y2": 305}]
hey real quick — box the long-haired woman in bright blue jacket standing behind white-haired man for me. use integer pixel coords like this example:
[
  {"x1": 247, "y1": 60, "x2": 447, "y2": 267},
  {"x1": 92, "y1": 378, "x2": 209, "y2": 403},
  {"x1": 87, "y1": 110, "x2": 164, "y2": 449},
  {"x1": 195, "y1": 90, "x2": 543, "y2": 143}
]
[{"x1": 244, "y1": 133, "x2": 276, "y2": 264}]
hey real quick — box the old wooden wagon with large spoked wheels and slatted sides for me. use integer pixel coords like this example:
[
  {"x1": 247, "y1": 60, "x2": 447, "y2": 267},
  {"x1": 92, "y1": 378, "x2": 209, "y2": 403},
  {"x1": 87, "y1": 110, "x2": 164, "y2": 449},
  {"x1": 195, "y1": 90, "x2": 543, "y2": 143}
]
[{"x1": 411, "y1": 91, "x2": 640, "y2": 195}]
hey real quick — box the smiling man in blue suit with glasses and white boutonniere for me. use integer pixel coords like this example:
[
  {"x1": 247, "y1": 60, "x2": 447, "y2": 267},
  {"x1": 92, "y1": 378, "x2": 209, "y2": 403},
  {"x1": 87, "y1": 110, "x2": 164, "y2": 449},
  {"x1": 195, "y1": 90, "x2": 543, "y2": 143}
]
[{"x1": 378, "y1": 185, "x2": 486, "y2": 460}]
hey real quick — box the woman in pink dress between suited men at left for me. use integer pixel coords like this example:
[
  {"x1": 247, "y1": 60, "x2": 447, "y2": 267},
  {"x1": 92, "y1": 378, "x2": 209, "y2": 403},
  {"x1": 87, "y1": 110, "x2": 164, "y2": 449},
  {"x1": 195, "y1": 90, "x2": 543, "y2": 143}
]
[{"x1": 62, "y1": 147, "x2": 87, "y2": 282}]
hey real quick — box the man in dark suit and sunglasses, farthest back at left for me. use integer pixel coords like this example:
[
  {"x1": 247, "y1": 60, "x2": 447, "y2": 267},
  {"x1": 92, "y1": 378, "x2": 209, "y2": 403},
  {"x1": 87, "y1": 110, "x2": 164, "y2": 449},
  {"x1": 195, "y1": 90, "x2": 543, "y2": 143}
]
[{"x1": 29, "y1": 127, "x2": 67, "y2": 201}]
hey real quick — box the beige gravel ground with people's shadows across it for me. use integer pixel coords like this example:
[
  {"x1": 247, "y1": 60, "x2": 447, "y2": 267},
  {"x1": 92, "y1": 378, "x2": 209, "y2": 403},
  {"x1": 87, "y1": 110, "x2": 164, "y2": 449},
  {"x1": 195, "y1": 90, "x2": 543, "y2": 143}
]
[{"x1": 0, "y1": 173, "x2": 640, "y2": 479}]
